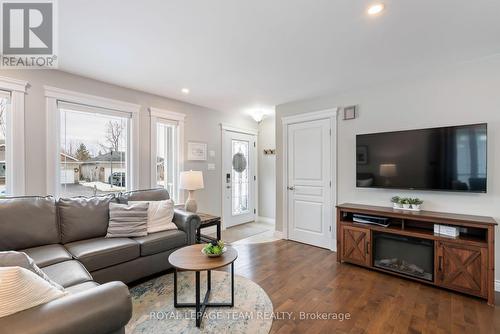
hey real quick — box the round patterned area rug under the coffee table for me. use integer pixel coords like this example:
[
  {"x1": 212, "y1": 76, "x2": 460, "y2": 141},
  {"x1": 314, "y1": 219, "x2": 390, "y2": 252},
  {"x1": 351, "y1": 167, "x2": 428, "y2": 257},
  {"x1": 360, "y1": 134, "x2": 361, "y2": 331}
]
[{"x1": 126, "y1": 271, "x2": 273, "y2": 334}]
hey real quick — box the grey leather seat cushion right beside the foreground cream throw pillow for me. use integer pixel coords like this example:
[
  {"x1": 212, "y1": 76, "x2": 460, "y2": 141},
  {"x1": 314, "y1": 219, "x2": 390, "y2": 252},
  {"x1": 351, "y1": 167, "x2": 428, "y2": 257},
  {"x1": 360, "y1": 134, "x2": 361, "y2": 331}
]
[{"x1": 42, "y1": 260, "x2": 92, "y2": 288}]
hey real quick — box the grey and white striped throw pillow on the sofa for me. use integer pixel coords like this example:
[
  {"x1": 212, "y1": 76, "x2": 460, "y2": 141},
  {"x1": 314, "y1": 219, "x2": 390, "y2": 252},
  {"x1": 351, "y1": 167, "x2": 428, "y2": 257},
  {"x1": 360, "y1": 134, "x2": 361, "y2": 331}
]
[{"x1": 106, "y1": 203, "x2": 149, "y2": 238}]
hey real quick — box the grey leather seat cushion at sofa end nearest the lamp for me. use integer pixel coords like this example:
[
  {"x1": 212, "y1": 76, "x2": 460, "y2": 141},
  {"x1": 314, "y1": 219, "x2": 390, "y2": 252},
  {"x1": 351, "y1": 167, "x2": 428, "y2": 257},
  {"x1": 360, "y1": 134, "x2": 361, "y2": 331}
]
[{"x1": 134, "y1": 230, "x2": 187, "y2": 256}]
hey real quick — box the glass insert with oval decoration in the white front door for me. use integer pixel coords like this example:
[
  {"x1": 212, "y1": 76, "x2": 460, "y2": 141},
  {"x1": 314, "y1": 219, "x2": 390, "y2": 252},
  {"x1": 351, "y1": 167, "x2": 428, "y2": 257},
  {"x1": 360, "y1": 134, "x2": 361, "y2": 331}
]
[{"x1": 231, "y1": 139, "x2": 250, "y2": 216}]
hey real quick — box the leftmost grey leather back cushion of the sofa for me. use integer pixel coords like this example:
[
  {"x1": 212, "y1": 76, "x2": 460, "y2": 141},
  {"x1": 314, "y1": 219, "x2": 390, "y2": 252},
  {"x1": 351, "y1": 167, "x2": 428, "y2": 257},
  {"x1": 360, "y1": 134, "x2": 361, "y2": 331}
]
[{"x1": 0, "y1": 197, "x2": 60, "y2": 251}]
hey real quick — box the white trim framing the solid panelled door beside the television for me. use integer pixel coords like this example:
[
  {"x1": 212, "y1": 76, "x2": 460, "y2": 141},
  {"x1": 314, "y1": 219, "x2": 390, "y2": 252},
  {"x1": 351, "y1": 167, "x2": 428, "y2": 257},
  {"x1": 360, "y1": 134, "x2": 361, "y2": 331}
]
[{"x1": 281, "y1": 107, "x2": 339, "y2": 251}]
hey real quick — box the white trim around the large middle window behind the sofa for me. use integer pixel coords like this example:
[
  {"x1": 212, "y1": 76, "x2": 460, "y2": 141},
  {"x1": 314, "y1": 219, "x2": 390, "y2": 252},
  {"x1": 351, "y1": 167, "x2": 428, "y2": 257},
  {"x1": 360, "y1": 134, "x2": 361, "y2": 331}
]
[{"x1": 44, "y1": 86, "x2": 141, "y2": 196}]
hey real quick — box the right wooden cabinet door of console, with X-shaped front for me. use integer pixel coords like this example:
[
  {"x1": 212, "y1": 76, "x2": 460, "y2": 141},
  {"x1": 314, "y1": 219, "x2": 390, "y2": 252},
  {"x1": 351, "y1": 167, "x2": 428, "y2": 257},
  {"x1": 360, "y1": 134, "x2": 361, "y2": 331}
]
[{"x1": 436, "y1": 241, "x2": 488, "y2": 297}]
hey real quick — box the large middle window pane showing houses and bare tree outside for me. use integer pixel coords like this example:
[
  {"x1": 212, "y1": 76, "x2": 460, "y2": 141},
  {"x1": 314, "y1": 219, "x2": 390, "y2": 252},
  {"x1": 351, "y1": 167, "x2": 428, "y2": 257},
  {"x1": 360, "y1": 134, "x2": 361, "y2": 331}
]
[{"x1": 59, "y1": 109, "x2": 129, "y2": 197}]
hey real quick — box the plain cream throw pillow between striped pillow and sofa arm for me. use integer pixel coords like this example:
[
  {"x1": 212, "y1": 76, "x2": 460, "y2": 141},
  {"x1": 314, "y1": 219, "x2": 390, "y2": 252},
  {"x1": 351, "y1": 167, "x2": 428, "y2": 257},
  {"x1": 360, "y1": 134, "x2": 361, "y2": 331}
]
[{"x1": 128, "y1": 199, "x2": 177, "y2": 233}]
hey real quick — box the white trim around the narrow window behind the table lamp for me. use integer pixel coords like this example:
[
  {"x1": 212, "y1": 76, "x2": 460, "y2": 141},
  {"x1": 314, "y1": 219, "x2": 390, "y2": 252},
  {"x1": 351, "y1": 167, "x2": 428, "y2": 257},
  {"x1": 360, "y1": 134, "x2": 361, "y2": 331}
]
[{"x1": 149, "y1": 107, "x2": 186, "y2": 202}]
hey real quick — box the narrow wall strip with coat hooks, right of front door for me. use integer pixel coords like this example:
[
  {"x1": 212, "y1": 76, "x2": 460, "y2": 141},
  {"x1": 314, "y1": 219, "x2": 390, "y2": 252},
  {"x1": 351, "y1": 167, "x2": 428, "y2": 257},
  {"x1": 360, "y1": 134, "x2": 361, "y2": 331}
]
[{"x1": 258, "y1": 115, "x2": 276, "y2": 219}]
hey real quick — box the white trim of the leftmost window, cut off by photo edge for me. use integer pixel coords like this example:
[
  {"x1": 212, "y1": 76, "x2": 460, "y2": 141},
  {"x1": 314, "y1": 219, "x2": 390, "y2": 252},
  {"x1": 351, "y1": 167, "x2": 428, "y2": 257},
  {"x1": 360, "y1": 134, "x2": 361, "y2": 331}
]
[{"x1": 0, "y1": 77, "x2": 28, "y2": 196}]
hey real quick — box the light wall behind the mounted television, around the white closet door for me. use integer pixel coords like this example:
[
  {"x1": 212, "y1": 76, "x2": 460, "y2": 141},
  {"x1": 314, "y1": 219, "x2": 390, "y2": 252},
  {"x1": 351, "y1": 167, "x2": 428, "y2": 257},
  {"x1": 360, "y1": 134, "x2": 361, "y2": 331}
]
[{"x1": 276, "y1": 57, "x2": 500, "y2": 279}]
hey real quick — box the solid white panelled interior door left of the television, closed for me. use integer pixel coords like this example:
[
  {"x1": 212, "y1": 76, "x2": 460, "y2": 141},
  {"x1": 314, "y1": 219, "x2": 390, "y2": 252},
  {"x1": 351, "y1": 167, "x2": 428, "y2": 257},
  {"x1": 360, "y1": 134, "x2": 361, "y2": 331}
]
[{"x1": 287, "y1": 119, "x2": 333, "y2": 248}]
